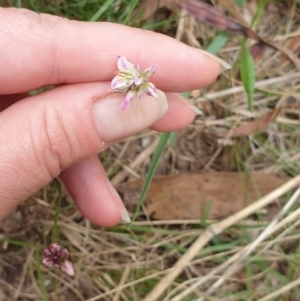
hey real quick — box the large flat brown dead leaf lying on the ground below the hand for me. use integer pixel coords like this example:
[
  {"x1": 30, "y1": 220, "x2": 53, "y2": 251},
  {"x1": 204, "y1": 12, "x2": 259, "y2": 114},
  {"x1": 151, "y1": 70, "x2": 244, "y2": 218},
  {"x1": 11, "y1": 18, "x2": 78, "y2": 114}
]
[{"x1": 118, "y1": 172, "x2": 289, "y2": 220}]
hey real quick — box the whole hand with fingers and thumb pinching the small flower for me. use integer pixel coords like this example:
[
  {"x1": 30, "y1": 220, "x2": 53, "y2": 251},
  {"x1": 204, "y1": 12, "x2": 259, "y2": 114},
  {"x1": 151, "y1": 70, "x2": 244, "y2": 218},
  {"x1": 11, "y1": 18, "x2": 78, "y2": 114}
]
[{"x1": 0, "y1": 8, "x2": 219, "y2": 226}]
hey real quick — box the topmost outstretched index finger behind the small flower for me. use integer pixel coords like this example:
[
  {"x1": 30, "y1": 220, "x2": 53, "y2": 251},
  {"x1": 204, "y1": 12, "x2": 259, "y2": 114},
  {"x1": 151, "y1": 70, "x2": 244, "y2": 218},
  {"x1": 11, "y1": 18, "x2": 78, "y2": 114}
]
[{"x1": 0, "y1": 8, "x2": 219, "y2": 94}]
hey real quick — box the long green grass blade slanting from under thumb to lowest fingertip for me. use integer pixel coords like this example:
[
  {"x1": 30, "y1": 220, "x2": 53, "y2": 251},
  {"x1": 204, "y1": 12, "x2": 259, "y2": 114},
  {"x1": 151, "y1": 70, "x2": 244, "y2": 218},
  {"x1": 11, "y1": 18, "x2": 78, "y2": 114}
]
[{"x1": 132, "y1": 133, "x2": 171, "y2": 222}]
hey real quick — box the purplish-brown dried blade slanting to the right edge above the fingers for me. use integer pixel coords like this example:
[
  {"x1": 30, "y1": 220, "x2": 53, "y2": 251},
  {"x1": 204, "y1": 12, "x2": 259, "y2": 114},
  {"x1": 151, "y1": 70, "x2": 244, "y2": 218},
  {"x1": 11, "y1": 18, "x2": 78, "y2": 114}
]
[{"x1": 181, "y1": 0, "x2": 300, "y2": 69}]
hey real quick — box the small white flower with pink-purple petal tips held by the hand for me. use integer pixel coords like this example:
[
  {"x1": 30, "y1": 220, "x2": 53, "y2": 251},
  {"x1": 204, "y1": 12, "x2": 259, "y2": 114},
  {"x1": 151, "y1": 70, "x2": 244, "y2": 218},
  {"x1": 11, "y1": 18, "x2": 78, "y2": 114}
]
[{"x1": 110, "y1": 56, "x2": 157, "y2": 110}]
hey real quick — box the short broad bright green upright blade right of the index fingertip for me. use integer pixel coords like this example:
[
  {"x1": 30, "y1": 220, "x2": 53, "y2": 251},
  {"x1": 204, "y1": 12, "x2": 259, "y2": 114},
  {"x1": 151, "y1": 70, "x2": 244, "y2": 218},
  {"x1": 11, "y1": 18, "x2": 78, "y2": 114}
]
[{"x1": 239, "y1": 39, "x2": 255, "y2": 112}]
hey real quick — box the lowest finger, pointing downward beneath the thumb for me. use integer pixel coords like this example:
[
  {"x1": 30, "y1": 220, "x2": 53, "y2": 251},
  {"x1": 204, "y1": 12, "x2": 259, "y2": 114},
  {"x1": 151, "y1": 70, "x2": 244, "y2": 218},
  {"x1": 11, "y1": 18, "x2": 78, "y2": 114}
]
[{"x1": 60, "y1": 157, "x2": 130, "y2": 227}]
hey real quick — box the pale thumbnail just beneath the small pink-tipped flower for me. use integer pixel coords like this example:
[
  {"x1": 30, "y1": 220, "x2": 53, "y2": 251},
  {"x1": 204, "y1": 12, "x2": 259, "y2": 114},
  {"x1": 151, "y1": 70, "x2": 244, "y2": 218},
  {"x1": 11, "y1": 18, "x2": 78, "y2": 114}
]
[{"x1": 93, "y1": 90, "x2": 168, "y2": 142}]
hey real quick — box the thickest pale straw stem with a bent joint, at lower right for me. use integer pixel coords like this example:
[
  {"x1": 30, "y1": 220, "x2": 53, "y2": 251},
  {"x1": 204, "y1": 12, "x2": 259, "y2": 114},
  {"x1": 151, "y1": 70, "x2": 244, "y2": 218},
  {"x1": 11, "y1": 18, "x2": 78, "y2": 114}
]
[{"x1": 144, "y1": 176, "x2": 300, "y2": 301}]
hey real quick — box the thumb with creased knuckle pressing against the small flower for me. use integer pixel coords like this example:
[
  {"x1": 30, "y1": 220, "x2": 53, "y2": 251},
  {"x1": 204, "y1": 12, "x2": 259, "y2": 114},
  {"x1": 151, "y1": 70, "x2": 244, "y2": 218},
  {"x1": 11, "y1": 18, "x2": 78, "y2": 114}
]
[{"x1": 0, "y1": 83, "x2": 168, "y2": 219}]
